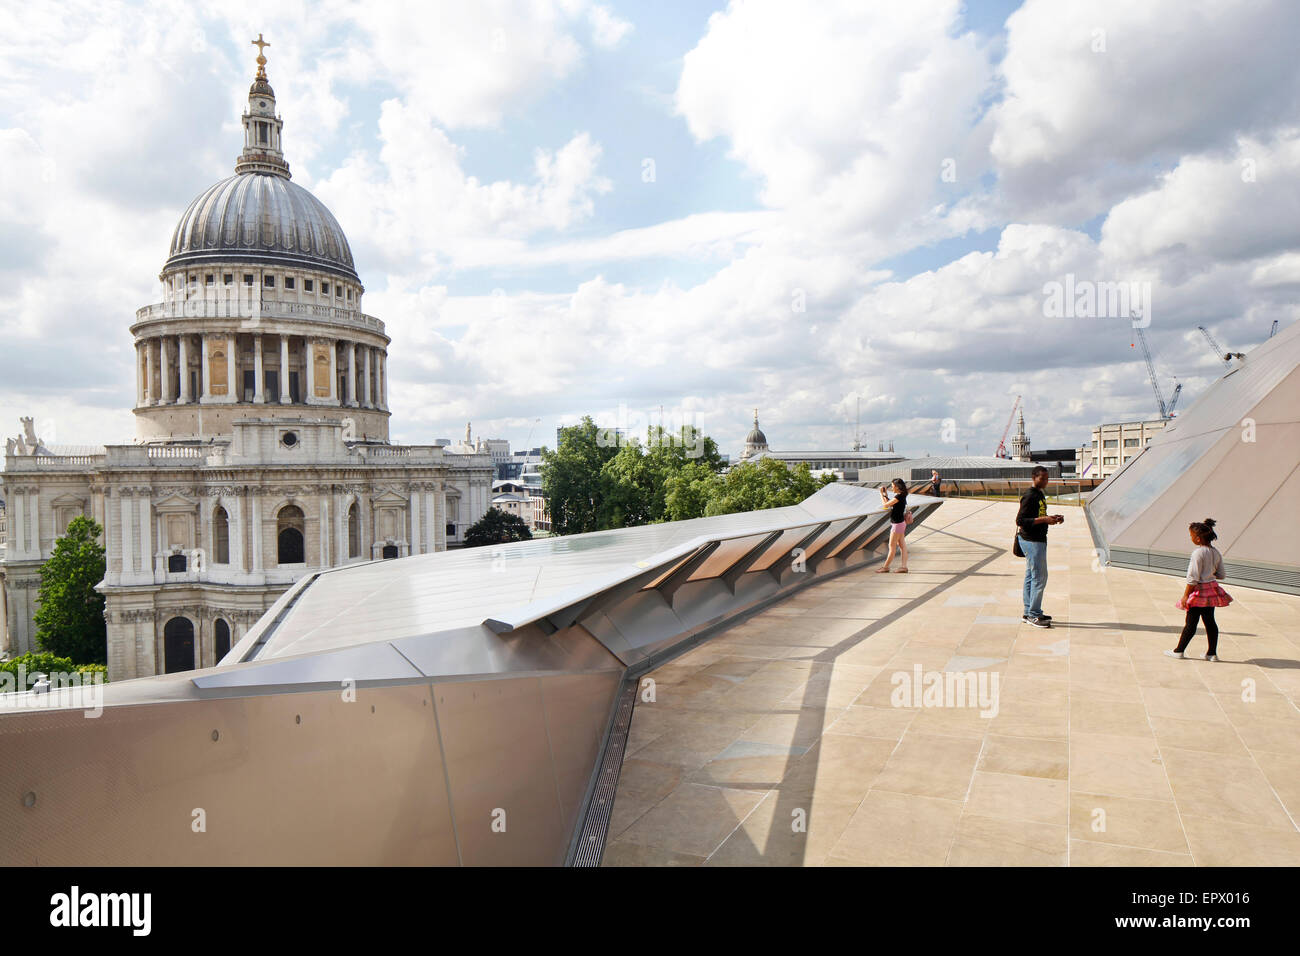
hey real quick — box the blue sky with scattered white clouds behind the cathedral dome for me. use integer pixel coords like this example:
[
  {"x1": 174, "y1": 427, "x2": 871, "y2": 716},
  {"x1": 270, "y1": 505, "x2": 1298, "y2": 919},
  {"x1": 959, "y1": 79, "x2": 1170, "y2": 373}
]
[{"x1": 0, "y1": 0, "x2": 1300, "y2": 455}]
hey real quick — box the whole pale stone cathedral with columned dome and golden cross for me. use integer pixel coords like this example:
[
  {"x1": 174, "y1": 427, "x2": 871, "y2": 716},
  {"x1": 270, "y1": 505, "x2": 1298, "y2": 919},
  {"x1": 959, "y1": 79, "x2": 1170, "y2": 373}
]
[{"x1": 0, "y1": 46, "x2": 493, "y2": 680}]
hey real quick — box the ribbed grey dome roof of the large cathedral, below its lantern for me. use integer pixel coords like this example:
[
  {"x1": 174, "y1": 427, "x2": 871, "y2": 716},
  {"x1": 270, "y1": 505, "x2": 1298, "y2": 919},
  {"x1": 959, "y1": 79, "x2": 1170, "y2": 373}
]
[{"x1": 163, "y1": 173, "x2": 360, "y2": 282}]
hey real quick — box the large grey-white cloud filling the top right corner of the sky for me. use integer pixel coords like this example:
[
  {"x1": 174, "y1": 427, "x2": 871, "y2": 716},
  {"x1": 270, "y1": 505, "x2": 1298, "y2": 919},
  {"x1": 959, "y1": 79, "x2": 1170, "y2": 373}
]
[{"x1": 991, "y1": 0, "x2": 1300, "y2": 221}]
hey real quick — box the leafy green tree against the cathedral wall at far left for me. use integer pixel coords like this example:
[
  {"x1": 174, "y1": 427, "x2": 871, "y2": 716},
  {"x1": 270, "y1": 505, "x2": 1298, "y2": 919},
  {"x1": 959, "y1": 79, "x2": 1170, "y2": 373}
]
[{"x1": 34, "y1": 515, "x2": 108, "y2": 663}]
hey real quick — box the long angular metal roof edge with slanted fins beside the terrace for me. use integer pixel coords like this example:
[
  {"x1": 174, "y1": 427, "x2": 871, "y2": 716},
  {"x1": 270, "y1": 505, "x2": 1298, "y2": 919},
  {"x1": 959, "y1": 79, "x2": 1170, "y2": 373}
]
[{"x1": 0, "y1": 484, "x2": 941, "y2": 865}]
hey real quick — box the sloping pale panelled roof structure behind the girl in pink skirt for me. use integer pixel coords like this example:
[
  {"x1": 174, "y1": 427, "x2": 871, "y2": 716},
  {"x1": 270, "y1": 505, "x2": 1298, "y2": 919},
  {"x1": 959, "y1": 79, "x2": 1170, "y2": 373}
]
[{"x1": 1086, "y1": 323, "x2": 1300, "y2": 594}]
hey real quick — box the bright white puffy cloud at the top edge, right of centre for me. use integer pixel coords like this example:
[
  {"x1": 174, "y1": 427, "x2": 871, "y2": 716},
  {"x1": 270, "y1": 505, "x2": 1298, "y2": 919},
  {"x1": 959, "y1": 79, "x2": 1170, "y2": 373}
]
[{"x1": 677, "y1": 0, "x2": 991, "y2": 232}]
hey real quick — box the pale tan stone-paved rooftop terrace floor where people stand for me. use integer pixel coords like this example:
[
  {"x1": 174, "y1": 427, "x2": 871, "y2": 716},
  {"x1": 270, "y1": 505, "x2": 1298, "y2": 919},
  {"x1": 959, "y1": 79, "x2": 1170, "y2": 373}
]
[{"x1": 603, "y1": 499, "x2": 1300, "y2": 866}]
